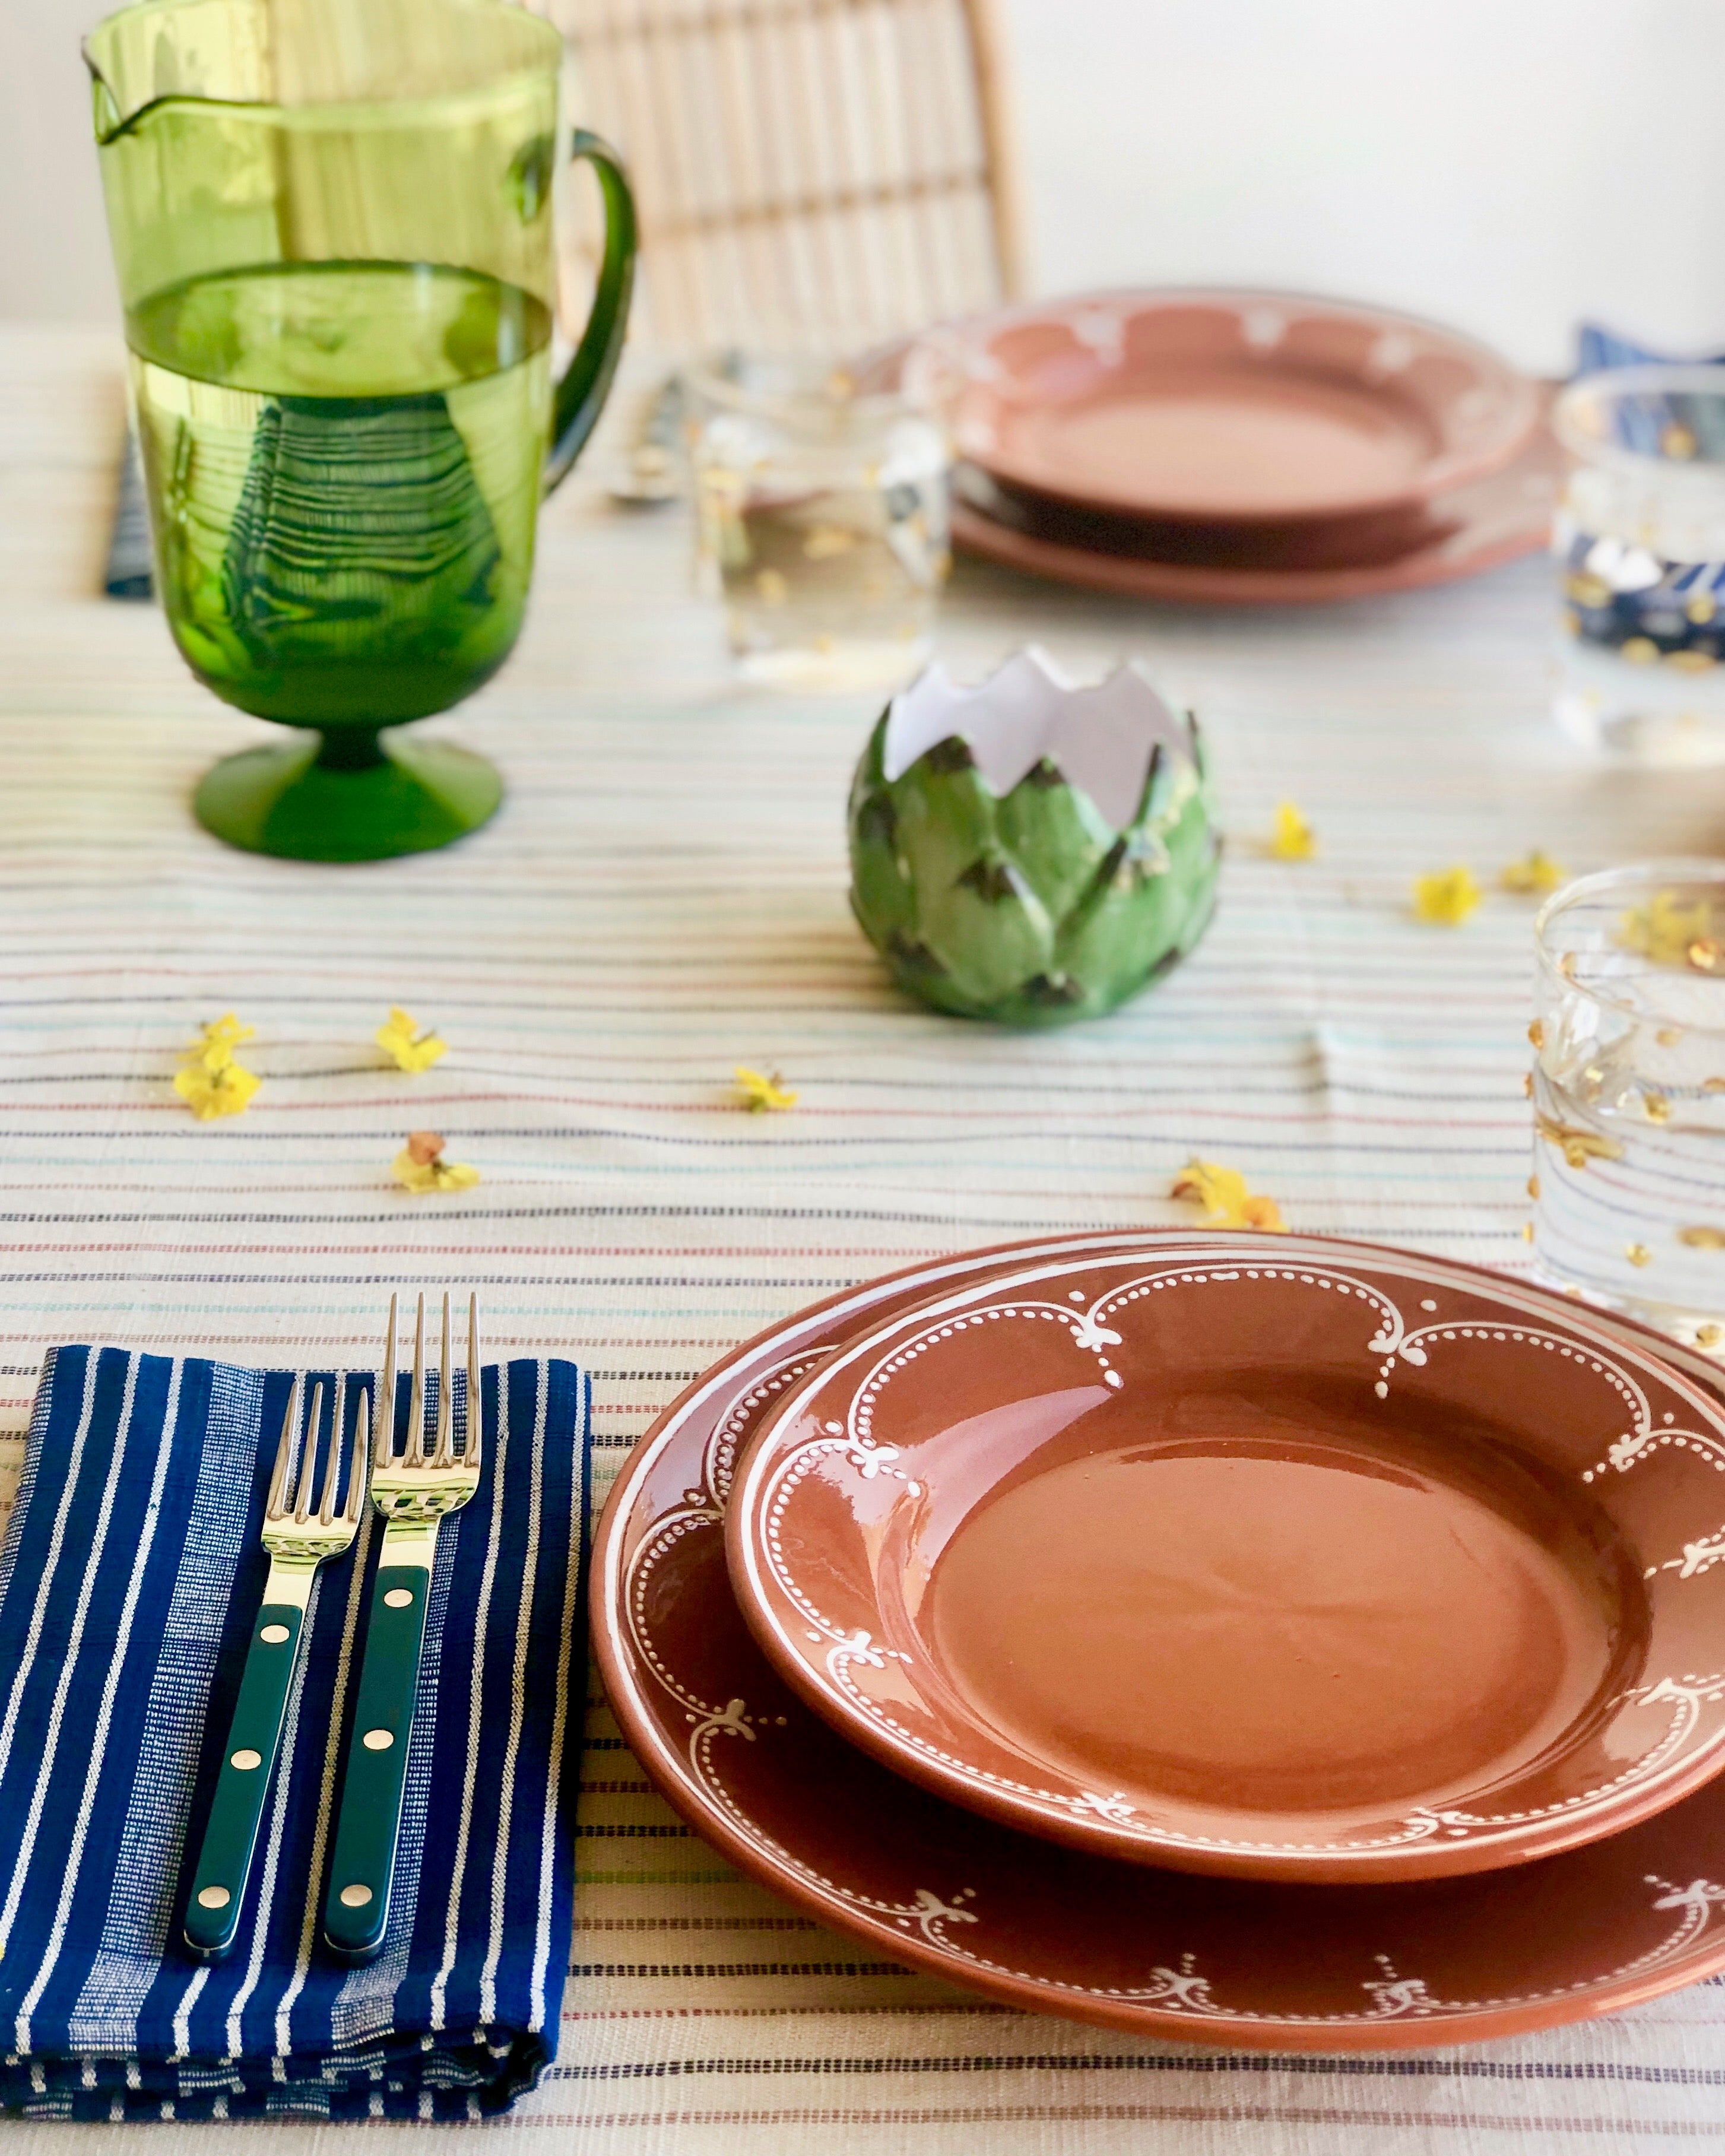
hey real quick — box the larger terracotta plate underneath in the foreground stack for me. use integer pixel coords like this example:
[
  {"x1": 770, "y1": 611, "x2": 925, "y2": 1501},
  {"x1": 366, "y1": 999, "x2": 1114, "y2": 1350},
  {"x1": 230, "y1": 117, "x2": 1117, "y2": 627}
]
[{"x1": 593, "y1": 1235, "x2": 1725, "y2": 2050}]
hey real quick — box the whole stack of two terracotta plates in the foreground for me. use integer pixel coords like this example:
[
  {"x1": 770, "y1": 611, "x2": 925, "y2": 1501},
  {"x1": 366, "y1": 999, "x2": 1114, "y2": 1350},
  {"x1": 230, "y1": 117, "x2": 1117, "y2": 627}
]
[{"x1": 593, "y1": 1234, "x2": 1725, "y2": 2050}]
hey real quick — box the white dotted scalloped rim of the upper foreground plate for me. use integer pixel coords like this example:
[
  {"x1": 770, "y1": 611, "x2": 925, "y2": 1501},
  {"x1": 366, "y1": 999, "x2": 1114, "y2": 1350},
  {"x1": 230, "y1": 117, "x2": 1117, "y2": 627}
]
[{"x1": 733, "y1": 1248, "x2": 1725, "y2": 1873}]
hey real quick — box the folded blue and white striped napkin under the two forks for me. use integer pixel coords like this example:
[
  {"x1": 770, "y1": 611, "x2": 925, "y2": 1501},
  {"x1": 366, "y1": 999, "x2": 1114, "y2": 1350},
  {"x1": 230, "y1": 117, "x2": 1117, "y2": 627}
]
[{"x1": 0, "y1": 1348, "x2": 589, "y2": 2119}]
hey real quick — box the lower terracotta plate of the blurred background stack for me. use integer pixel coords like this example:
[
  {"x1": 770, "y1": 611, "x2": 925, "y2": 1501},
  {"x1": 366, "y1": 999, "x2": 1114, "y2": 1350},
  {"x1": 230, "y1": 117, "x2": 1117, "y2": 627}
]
[{"x1": 953, "y1": 427, "x2": 1565, "y2": 606}]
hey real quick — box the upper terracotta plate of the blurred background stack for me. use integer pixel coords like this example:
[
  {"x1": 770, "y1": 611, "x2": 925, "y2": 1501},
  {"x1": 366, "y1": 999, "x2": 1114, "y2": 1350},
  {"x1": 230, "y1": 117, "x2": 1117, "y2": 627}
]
[{"x1": 908, "y1": 291, "x2": 1540, "y2": 524}]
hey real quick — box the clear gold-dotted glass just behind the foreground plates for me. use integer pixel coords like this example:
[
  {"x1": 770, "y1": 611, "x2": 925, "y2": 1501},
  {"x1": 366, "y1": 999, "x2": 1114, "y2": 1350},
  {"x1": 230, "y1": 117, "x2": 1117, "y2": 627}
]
[{"x1": 1529, "y1": 860, "x2": 1725, "y2": 1352}]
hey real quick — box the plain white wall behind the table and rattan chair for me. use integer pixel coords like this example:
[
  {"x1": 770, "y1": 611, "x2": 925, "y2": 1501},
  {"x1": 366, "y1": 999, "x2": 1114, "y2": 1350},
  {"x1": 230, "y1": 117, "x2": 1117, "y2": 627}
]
[{"x1": 0, "y1": 0, "x2": 1725, "y2": 369}]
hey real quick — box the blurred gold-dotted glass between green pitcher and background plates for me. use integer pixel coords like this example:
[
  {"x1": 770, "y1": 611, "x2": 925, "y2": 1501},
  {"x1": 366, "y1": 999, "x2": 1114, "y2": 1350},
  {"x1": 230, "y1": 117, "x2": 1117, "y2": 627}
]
[{"x1": 686, "y1": 360, "x2": 951, "y2": 690}]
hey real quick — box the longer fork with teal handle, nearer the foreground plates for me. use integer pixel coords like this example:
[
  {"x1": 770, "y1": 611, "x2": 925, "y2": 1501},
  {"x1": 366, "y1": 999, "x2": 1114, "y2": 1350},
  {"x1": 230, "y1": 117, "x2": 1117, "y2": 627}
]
[{"x1": 324, "y1": 1296, "x2": 485, "y2": 1962}]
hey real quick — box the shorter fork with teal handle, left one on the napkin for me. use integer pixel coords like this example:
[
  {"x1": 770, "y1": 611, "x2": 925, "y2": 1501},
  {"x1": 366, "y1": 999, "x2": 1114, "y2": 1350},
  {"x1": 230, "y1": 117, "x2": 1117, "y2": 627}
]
[{"x1": 185, "y1": 1375, "x2": 371, "y2": 1962}]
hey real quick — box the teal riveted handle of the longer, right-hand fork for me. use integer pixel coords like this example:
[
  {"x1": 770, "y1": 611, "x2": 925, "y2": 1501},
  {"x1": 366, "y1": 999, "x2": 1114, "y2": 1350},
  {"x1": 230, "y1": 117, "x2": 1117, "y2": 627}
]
[{"x1": 324, "y1": 1565, "x2": 432, "y2": 1962}]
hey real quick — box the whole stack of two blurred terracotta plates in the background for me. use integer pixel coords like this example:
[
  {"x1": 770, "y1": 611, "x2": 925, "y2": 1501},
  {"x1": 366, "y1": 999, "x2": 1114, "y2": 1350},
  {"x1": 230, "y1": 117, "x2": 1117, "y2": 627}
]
[{"x1": 906, "y1": 291, "x2": 1561, "y2": 604}]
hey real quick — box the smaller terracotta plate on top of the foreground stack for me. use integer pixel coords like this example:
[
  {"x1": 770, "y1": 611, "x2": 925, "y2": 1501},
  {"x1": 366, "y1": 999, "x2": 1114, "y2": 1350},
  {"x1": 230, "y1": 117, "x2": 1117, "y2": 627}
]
[{"x1": 727, "y1": 1239, "x2": 1725, "y2": 1880}]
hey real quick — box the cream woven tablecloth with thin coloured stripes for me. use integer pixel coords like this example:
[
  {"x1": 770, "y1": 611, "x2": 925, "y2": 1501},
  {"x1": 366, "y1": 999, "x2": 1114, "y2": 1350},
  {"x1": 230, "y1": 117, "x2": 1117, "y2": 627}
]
[{"x1": 0, "y1": 330, "x2": 1725, "y2": 2156}]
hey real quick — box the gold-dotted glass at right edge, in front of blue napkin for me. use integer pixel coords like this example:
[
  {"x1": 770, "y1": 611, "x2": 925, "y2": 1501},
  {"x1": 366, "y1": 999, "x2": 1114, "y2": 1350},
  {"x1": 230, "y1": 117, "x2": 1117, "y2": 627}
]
[{"x1": 1552, "y1": 366, "x2": 1725, "y2": 765}]
